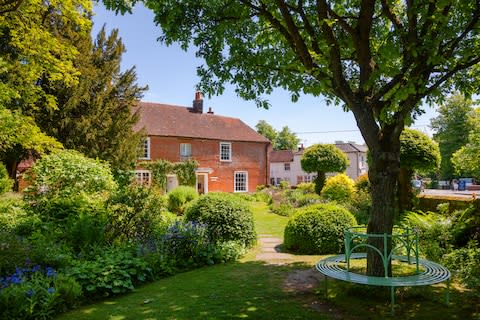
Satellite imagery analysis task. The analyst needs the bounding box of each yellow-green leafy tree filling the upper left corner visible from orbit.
[0,0,92,178]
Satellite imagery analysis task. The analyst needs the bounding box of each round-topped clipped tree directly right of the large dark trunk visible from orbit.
[398,128,440,212]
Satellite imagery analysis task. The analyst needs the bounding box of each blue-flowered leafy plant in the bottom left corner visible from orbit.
[0,265,82,319]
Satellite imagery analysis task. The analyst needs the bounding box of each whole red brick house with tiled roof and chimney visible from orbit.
[135,92,270,193]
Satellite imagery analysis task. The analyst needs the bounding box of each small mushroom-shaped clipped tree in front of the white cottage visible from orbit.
[300,144,349,194]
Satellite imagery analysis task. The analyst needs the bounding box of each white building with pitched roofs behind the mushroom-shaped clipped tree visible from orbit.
[270,141,368,186]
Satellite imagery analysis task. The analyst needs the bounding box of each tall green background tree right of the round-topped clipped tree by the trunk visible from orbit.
[431,93,473,180]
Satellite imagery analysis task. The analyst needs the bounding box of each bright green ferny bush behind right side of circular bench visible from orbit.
[402,211,452,262]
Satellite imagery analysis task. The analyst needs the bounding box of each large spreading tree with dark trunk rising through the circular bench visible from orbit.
[104,0,480,276]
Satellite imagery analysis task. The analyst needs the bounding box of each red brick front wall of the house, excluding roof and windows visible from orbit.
[142,136,270,192]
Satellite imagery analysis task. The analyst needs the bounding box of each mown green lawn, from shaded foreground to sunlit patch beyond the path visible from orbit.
[59,203,480,320]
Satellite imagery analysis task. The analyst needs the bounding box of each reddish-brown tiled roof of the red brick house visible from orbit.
[134,102,269,142]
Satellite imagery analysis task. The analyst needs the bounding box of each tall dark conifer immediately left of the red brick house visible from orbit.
[36,27,146,169]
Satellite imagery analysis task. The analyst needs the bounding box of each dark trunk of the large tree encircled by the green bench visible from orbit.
[367,148,400,277]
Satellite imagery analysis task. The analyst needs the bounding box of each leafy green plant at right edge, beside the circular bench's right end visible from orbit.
[442,241,480,289]
